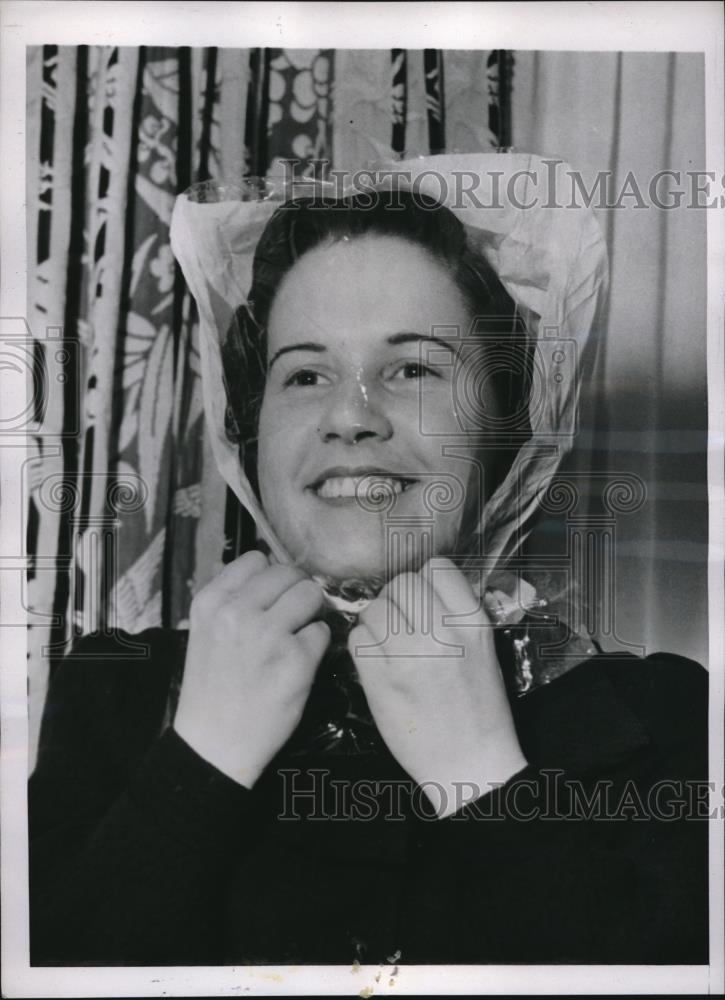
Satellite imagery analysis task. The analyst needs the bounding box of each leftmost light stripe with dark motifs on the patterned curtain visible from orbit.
[26,46,78,757]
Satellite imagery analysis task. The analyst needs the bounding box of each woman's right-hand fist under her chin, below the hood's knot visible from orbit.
[349,559,527,816]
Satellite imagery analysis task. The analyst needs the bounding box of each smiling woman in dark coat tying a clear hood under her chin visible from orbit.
[30,157,707,965]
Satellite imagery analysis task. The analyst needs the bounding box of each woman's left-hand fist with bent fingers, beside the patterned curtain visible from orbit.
[174,552,330,788]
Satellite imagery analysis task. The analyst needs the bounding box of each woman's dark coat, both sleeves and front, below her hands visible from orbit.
[29,629,708,965]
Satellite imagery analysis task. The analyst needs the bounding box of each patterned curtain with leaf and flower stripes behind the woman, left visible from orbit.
[27,45,513,764]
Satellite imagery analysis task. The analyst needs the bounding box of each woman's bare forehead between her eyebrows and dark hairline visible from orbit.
[269,235,469,342]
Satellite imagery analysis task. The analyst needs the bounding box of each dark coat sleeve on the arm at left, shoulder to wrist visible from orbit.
[29,630,264,965]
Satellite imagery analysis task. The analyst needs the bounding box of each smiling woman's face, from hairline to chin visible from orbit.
[258,235,493,582]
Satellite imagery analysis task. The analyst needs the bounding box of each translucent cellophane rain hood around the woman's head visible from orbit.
[171,152,607,636]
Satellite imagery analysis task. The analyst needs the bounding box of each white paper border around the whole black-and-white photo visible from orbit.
[0,0,725,997]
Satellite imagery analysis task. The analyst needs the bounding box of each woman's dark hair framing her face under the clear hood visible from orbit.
[222,190,530,492]
